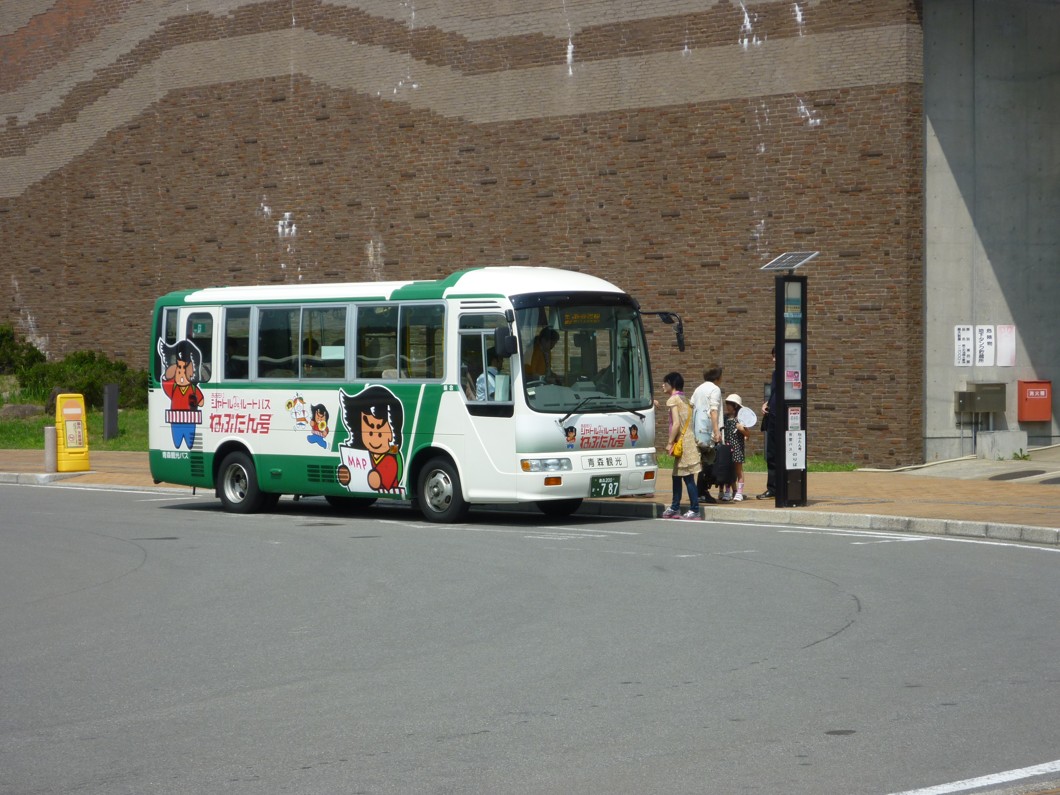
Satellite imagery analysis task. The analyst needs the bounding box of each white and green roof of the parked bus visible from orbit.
[160,265,622,304]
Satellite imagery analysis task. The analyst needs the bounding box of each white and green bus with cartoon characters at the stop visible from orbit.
[148,266,657,523]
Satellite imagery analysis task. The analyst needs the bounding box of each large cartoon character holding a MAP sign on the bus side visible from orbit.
[336,386,405,494]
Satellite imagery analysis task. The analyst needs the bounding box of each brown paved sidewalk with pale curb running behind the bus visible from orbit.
[0,445,1060,546]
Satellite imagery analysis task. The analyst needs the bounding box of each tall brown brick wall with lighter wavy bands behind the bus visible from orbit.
[0,0,924,466]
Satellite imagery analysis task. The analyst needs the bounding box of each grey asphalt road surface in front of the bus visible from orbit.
[0,485,1060,795]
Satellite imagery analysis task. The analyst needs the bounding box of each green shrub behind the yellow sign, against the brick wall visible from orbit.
[18,351,147,408]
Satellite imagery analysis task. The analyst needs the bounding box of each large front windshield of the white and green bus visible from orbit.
[512,293,652,413]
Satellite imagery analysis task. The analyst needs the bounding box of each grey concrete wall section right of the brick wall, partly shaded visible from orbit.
[923,0,1060,460]
